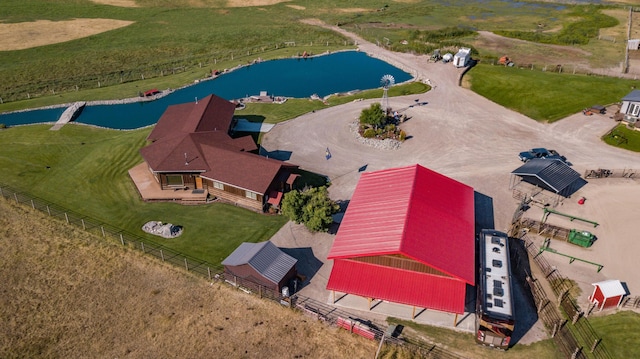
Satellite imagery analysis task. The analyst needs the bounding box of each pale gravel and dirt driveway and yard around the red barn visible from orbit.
[262,21,640,343]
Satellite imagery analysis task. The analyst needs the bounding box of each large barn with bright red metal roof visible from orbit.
[327,165,475,314]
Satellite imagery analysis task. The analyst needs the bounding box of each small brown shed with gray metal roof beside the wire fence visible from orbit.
[222,241,298,292]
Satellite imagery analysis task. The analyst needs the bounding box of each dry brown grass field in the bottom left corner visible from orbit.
[0,198,377,358]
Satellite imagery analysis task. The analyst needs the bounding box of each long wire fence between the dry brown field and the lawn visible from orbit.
[0,184,463,359]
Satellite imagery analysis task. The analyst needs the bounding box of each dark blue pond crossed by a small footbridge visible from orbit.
[0,51,412,129]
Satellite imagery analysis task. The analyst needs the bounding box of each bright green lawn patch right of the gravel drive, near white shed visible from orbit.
[467,64,640,122]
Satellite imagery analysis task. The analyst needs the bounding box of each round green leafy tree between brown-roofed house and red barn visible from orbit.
[282,186,340,232]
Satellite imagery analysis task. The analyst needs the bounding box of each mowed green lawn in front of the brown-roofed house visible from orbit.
[0,125,286,264]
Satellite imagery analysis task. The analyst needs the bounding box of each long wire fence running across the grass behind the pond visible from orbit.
[0,39,355,103]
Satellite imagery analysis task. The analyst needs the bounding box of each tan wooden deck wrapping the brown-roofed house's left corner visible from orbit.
[129,162,209,203]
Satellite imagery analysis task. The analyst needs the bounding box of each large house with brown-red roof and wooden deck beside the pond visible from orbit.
[129,95,297,212]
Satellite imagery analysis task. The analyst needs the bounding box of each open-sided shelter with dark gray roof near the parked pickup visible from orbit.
[511,158,587,198]
